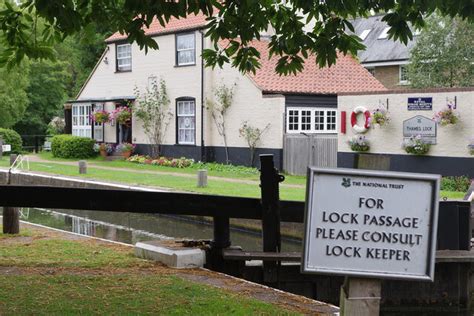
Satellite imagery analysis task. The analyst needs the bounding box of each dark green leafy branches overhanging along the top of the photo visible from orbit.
[0,0,474,74]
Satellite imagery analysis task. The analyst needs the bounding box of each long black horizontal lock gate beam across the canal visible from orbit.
[0,185,304,222]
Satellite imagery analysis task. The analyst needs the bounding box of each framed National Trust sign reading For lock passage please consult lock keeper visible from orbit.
[301,168,440,281]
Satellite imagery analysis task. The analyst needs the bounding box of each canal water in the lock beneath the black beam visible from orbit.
[0,208,301,251]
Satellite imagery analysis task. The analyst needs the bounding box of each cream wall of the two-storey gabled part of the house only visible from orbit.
[78,31,201,145]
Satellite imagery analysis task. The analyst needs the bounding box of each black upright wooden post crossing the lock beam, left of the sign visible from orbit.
[260,155,284,283]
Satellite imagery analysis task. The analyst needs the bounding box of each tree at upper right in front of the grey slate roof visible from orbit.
[408,15,474,88]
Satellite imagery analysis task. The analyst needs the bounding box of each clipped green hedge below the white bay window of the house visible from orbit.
[51,135,97,159]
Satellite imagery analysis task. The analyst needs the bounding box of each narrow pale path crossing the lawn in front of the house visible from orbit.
[28,155,305,189]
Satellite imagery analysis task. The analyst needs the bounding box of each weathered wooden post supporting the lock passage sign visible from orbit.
[339,154,390,316]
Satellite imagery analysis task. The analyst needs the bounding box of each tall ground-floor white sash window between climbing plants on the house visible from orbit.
[176,99,196,145]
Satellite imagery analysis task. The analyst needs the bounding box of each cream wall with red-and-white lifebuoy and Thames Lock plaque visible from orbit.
[338,89,474,157]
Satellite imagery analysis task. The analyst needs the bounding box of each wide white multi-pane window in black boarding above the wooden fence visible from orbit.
[286,107,337,134]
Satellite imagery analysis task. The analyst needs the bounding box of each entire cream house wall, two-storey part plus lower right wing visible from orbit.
[78,31,285,148]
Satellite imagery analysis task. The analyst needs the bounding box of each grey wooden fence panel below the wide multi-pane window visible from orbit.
[283,134,337,175]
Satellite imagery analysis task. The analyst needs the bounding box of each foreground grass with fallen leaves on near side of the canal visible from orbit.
[0,226,296,315]
